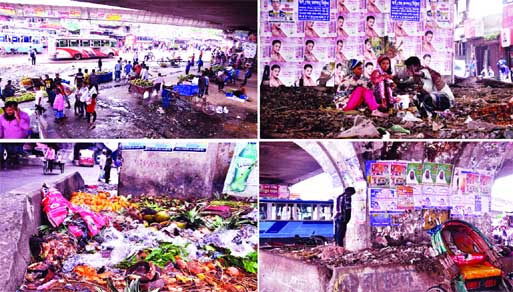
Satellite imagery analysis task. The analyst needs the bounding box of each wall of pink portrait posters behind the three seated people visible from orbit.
[259,0,454,86]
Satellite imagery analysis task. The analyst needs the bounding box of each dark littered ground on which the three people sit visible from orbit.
[261,78,513,139]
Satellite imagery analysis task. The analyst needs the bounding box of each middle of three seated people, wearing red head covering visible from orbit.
[370,55,395,111]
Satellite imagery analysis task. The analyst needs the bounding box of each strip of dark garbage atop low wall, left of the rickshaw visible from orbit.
[262,244,443,274]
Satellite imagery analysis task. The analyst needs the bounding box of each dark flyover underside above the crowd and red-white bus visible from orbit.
[77,0,258,31]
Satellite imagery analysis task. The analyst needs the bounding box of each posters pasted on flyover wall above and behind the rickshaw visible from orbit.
[366,161,494,245]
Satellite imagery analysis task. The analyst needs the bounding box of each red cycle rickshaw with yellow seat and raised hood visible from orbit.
[426,220,513,292]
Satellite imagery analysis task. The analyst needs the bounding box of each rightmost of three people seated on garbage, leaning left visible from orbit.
[405,56,454,118]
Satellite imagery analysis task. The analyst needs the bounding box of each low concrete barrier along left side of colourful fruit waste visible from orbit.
[0,172,84,291]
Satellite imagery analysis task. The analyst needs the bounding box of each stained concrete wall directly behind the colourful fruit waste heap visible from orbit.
[119,143,234,199]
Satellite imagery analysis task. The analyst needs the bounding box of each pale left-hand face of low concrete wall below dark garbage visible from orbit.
[258,250,331,292]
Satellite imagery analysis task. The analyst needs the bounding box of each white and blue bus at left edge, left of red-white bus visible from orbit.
[0,31,43,54]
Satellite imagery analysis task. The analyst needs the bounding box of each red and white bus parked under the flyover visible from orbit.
[48,36,119,60]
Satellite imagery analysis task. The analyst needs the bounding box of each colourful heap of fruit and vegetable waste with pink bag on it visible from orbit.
[20,188,258,292]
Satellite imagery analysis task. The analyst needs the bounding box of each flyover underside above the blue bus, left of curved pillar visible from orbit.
[260,142,323,185]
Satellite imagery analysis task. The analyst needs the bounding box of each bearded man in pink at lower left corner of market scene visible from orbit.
[0,100,30,139]
